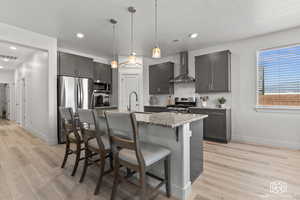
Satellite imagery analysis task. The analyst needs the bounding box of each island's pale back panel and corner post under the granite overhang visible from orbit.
[139,124,191,200]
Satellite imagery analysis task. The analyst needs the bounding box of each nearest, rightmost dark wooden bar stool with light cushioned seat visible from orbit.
[105,112,171,200]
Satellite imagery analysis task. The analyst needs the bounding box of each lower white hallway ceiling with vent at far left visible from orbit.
[0,42,36,70]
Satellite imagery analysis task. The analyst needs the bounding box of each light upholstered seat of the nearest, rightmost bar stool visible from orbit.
[119,142,171,167]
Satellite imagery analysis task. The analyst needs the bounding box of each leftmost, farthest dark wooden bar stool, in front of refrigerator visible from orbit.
[59,107,84,176]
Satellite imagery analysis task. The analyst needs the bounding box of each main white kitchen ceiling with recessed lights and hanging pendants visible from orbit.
[0,0,300,57]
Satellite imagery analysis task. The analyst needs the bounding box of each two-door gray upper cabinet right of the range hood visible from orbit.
[195,50,231,93]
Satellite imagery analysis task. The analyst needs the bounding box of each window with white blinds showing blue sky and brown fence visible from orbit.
[257,45,300,106]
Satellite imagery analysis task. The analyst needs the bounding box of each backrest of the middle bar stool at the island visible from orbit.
[78,109,107,150]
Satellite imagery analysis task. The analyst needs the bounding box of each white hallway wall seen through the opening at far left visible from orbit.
[15,51,49,140]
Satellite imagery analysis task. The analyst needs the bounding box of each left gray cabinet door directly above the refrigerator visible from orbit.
[58,52,77,76]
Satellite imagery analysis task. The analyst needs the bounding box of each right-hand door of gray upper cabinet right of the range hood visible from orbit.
[211,51,229,92]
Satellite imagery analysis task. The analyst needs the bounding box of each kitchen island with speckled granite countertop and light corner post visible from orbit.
[97,109,207,200]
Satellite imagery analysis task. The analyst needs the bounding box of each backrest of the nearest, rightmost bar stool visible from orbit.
[105,111,145,166]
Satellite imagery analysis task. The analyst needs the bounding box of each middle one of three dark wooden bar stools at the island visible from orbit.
[78,109,113,195]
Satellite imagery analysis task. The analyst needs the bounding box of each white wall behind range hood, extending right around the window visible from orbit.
[144,28,300,149]
